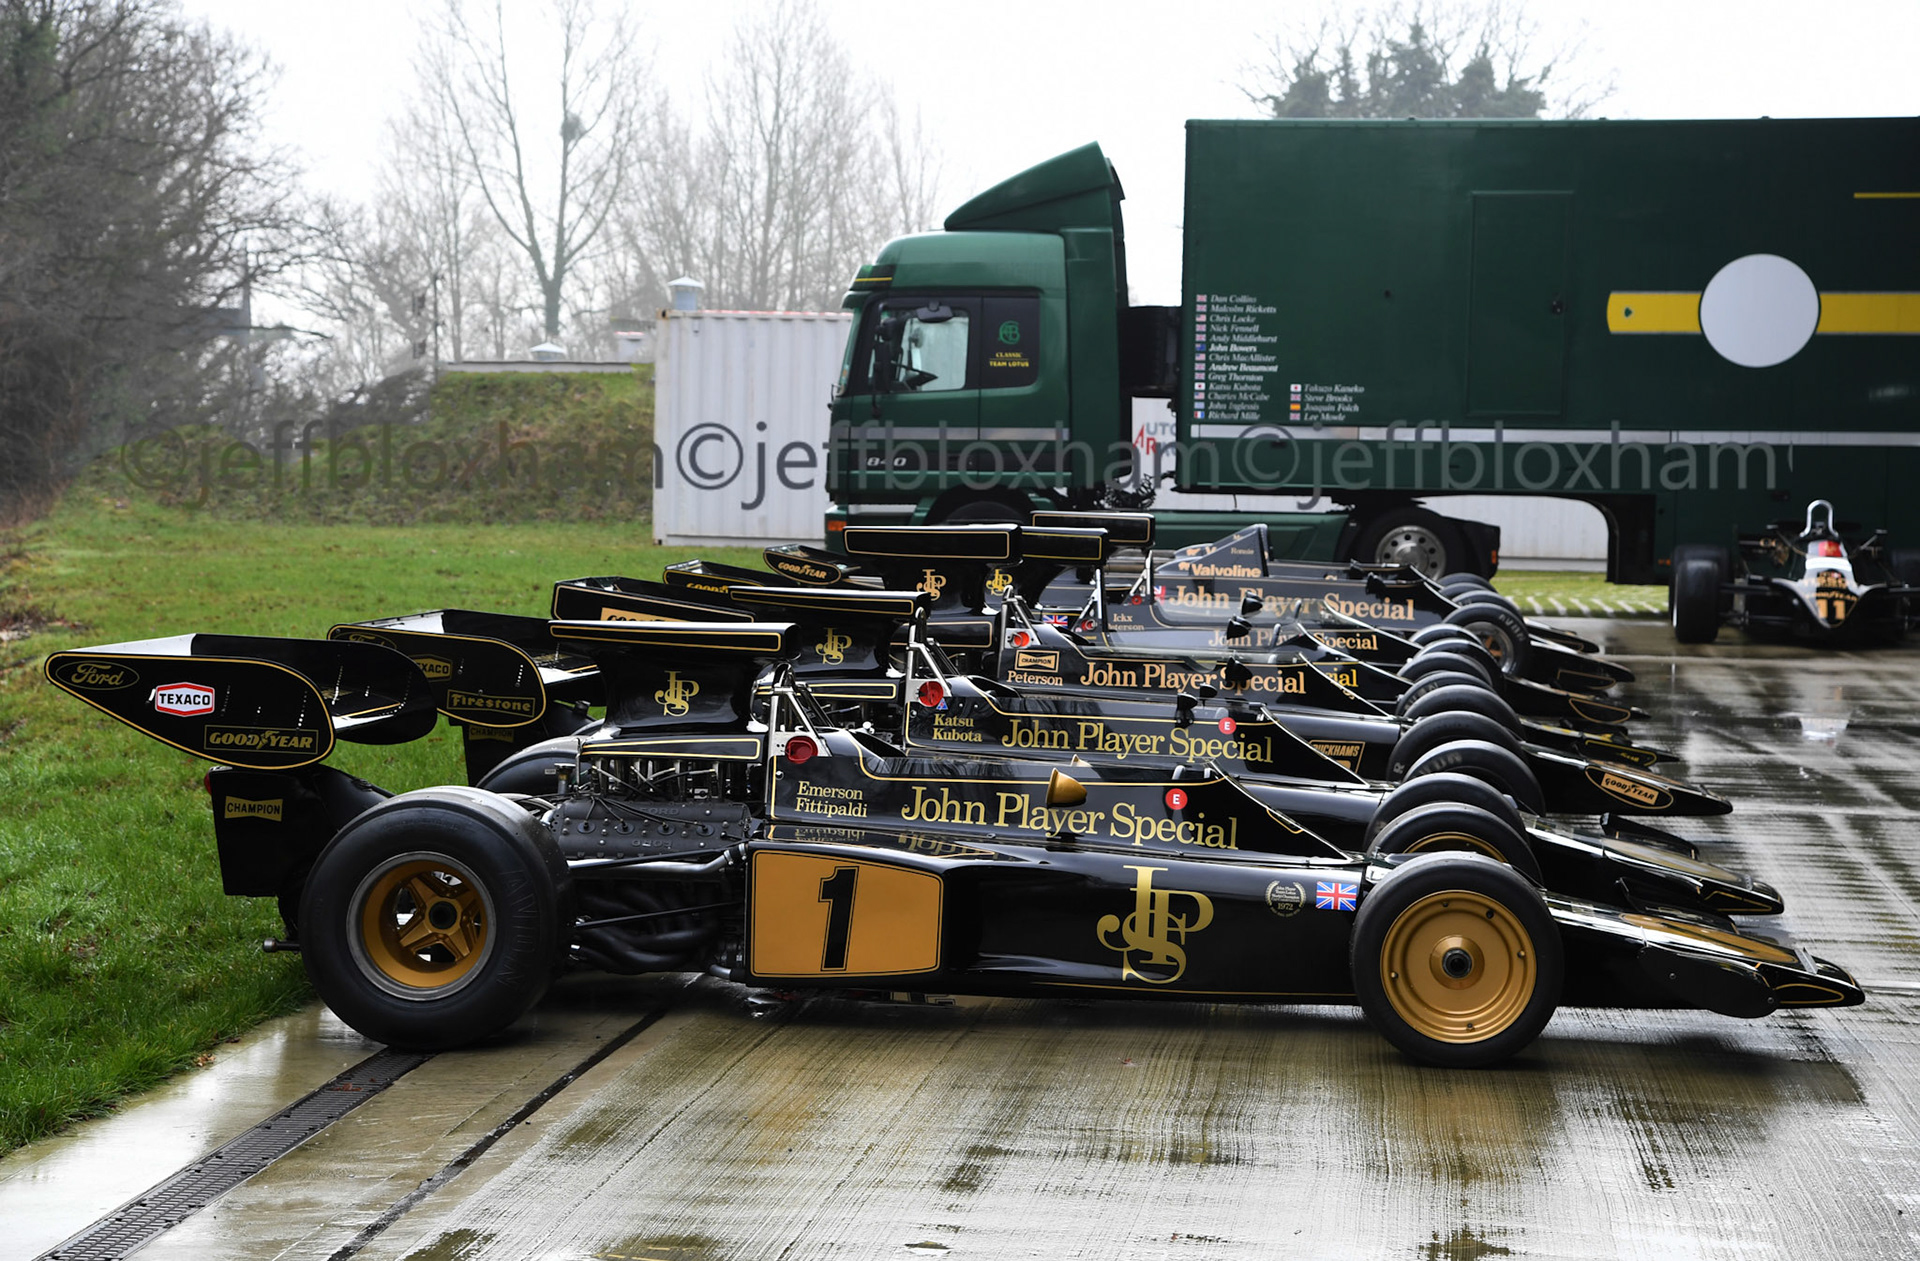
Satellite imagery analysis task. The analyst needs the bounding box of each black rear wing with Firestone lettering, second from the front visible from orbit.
[326,608,601,727]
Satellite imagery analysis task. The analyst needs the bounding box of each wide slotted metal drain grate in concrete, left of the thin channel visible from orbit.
[38,1050,430,1261]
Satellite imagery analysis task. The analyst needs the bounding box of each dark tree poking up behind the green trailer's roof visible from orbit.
[1242,0,1613,119]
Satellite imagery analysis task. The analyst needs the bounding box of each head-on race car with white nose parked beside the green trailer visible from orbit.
[1668,499,1920,643]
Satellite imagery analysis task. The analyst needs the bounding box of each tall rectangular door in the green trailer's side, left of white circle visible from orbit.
[1467,192,1572,416]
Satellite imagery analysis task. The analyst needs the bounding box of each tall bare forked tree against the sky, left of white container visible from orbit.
[426,0,647,340]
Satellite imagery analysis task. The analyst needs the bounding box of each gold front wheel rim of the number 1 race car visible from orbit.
[1380,889,1540,1042]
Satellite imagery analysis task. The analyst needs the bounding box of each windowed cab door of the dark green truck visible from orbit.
[843,294,981,491]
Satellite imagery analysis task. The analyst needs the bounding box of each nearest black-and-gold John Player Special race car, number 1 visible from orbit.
[46,620,1864,1065]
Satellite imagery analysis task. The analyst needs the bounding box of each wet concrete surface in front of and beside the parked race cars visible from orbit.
[11,620,1920,1261]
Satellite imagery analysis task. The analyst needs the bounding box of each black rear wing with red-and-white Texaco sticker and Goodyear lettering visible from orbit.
[46,635,440,770]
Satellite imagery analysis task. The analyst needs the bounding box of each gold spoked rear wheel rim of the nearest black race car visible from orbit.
[348,852,493,1000]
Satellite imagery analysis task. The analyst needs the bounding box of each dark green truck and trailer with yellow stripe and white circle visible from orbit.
[828,119,1920,582]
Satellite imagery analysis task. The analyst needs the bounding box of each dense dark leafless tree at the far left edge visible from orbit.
[0,0,307,516]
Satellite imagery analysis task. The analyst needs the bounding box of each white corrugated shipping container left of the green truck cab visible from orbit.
[653,311,852,547]
